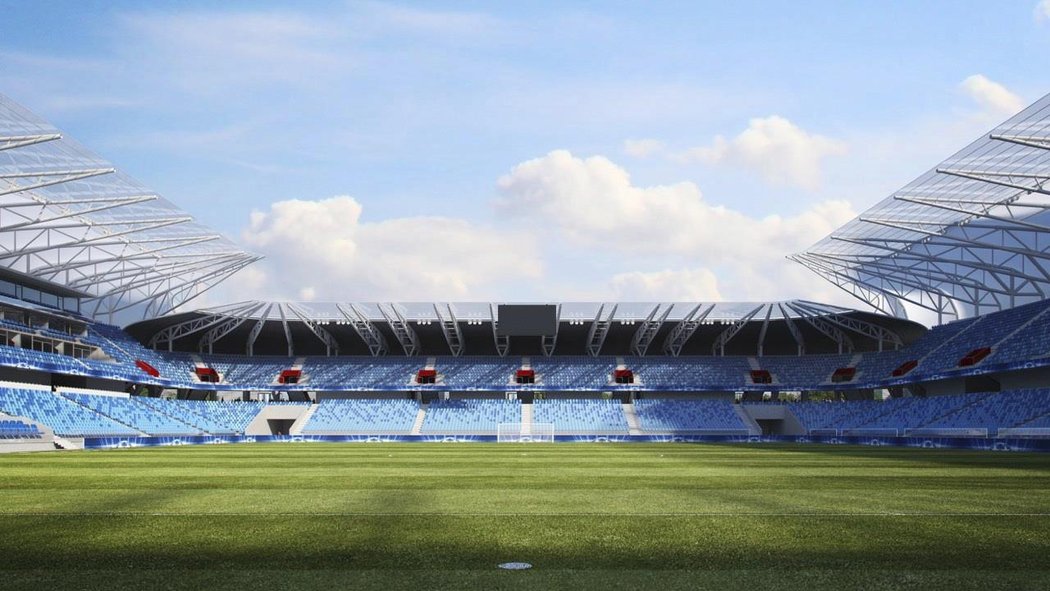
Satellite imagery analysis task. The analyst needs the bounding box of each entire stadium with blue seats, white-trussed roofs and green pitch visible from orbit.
[0,3,1050,589]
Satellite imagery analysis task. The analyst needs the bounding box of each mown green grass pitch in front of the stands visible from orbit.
[0,444,1050,591]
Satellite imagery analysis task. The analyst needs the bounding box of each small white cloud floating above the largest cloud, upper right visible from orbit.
[676,115,846,189]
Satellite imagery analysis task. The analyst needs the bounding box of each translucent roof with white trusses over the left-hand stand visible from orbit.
[0,94,259,322]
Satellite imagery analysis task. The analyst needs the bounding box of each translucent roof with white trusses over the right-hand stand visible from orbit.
[791,94,1050,321]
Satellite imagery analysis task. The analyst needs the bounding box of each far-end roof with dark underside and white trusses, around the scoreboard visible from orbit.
[127,300,924,356]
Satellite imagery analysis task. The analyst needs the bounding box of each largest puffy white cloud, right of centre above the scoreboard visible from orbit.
[497,150,856,299]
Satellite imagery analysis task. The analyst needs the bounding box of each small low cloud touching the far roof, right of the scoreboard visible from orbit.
[609,269,722,301]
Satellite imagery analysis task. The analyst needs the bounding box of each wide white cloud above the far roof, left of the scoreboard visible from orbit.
[233,196,542,301]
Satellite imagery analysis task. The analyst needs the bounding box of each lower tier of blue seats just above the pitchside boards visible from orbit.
[6,387,1050,437]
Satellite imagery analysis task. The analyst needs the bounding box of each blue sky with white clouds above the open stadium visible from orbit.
[0,0,1050,312]
